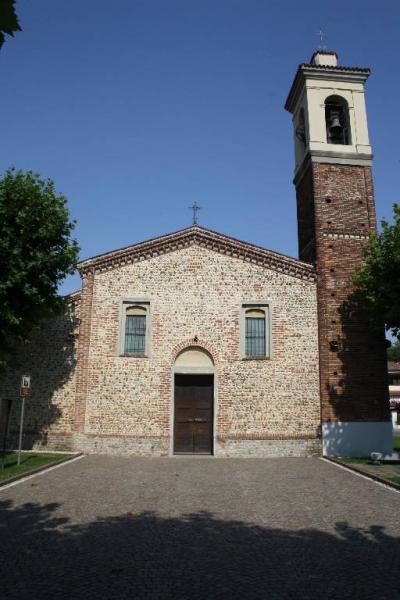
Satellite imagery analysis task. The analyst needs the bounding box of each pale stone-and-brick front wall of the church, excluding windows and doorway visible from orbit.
[75,245,320,456]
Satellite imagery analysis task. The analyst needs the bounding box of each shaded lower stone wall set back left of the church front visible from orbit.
[0,294,80,450]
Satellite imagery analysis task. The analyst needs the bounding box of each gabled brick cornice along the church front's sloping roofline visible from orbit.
[78,225,316,281]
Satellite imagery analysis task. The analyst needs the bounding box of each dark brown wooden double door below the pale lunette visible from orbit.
[174,374,214,454]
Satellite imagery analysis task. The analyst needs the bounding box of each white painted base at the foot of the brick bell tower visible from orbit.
[322,421,392,456]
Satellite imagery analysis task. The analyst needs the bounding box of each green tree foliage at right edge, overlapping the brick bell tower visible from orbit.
[354,204,400,339]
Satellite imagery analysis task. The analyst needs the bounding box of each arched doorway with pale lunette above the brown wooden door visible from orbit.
[173,347,214,454]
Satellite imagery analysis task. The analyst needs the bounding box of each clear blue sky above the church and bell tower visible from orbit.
[0,0,400,293]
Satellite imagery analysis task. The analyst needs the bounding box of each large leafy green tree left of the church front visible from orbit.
[0,169,79,372]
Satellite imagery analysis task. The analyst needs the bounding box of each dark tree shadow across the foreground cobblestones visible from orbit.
[0,501,400,600]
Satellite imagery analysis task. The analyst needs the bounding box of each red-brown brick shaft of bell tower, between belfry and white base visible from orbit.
[296,163,388,421]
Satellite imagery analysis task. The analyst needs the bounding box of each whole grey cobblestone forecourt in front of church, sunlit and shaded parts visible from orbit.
[0,456,400,600]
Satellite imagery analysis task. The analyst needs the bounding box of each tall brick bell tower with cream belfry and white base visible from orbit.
[285,51,391,456]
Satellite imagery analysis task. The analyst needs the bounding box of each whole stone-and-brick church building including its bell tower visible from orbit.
[2,52,391,457]
